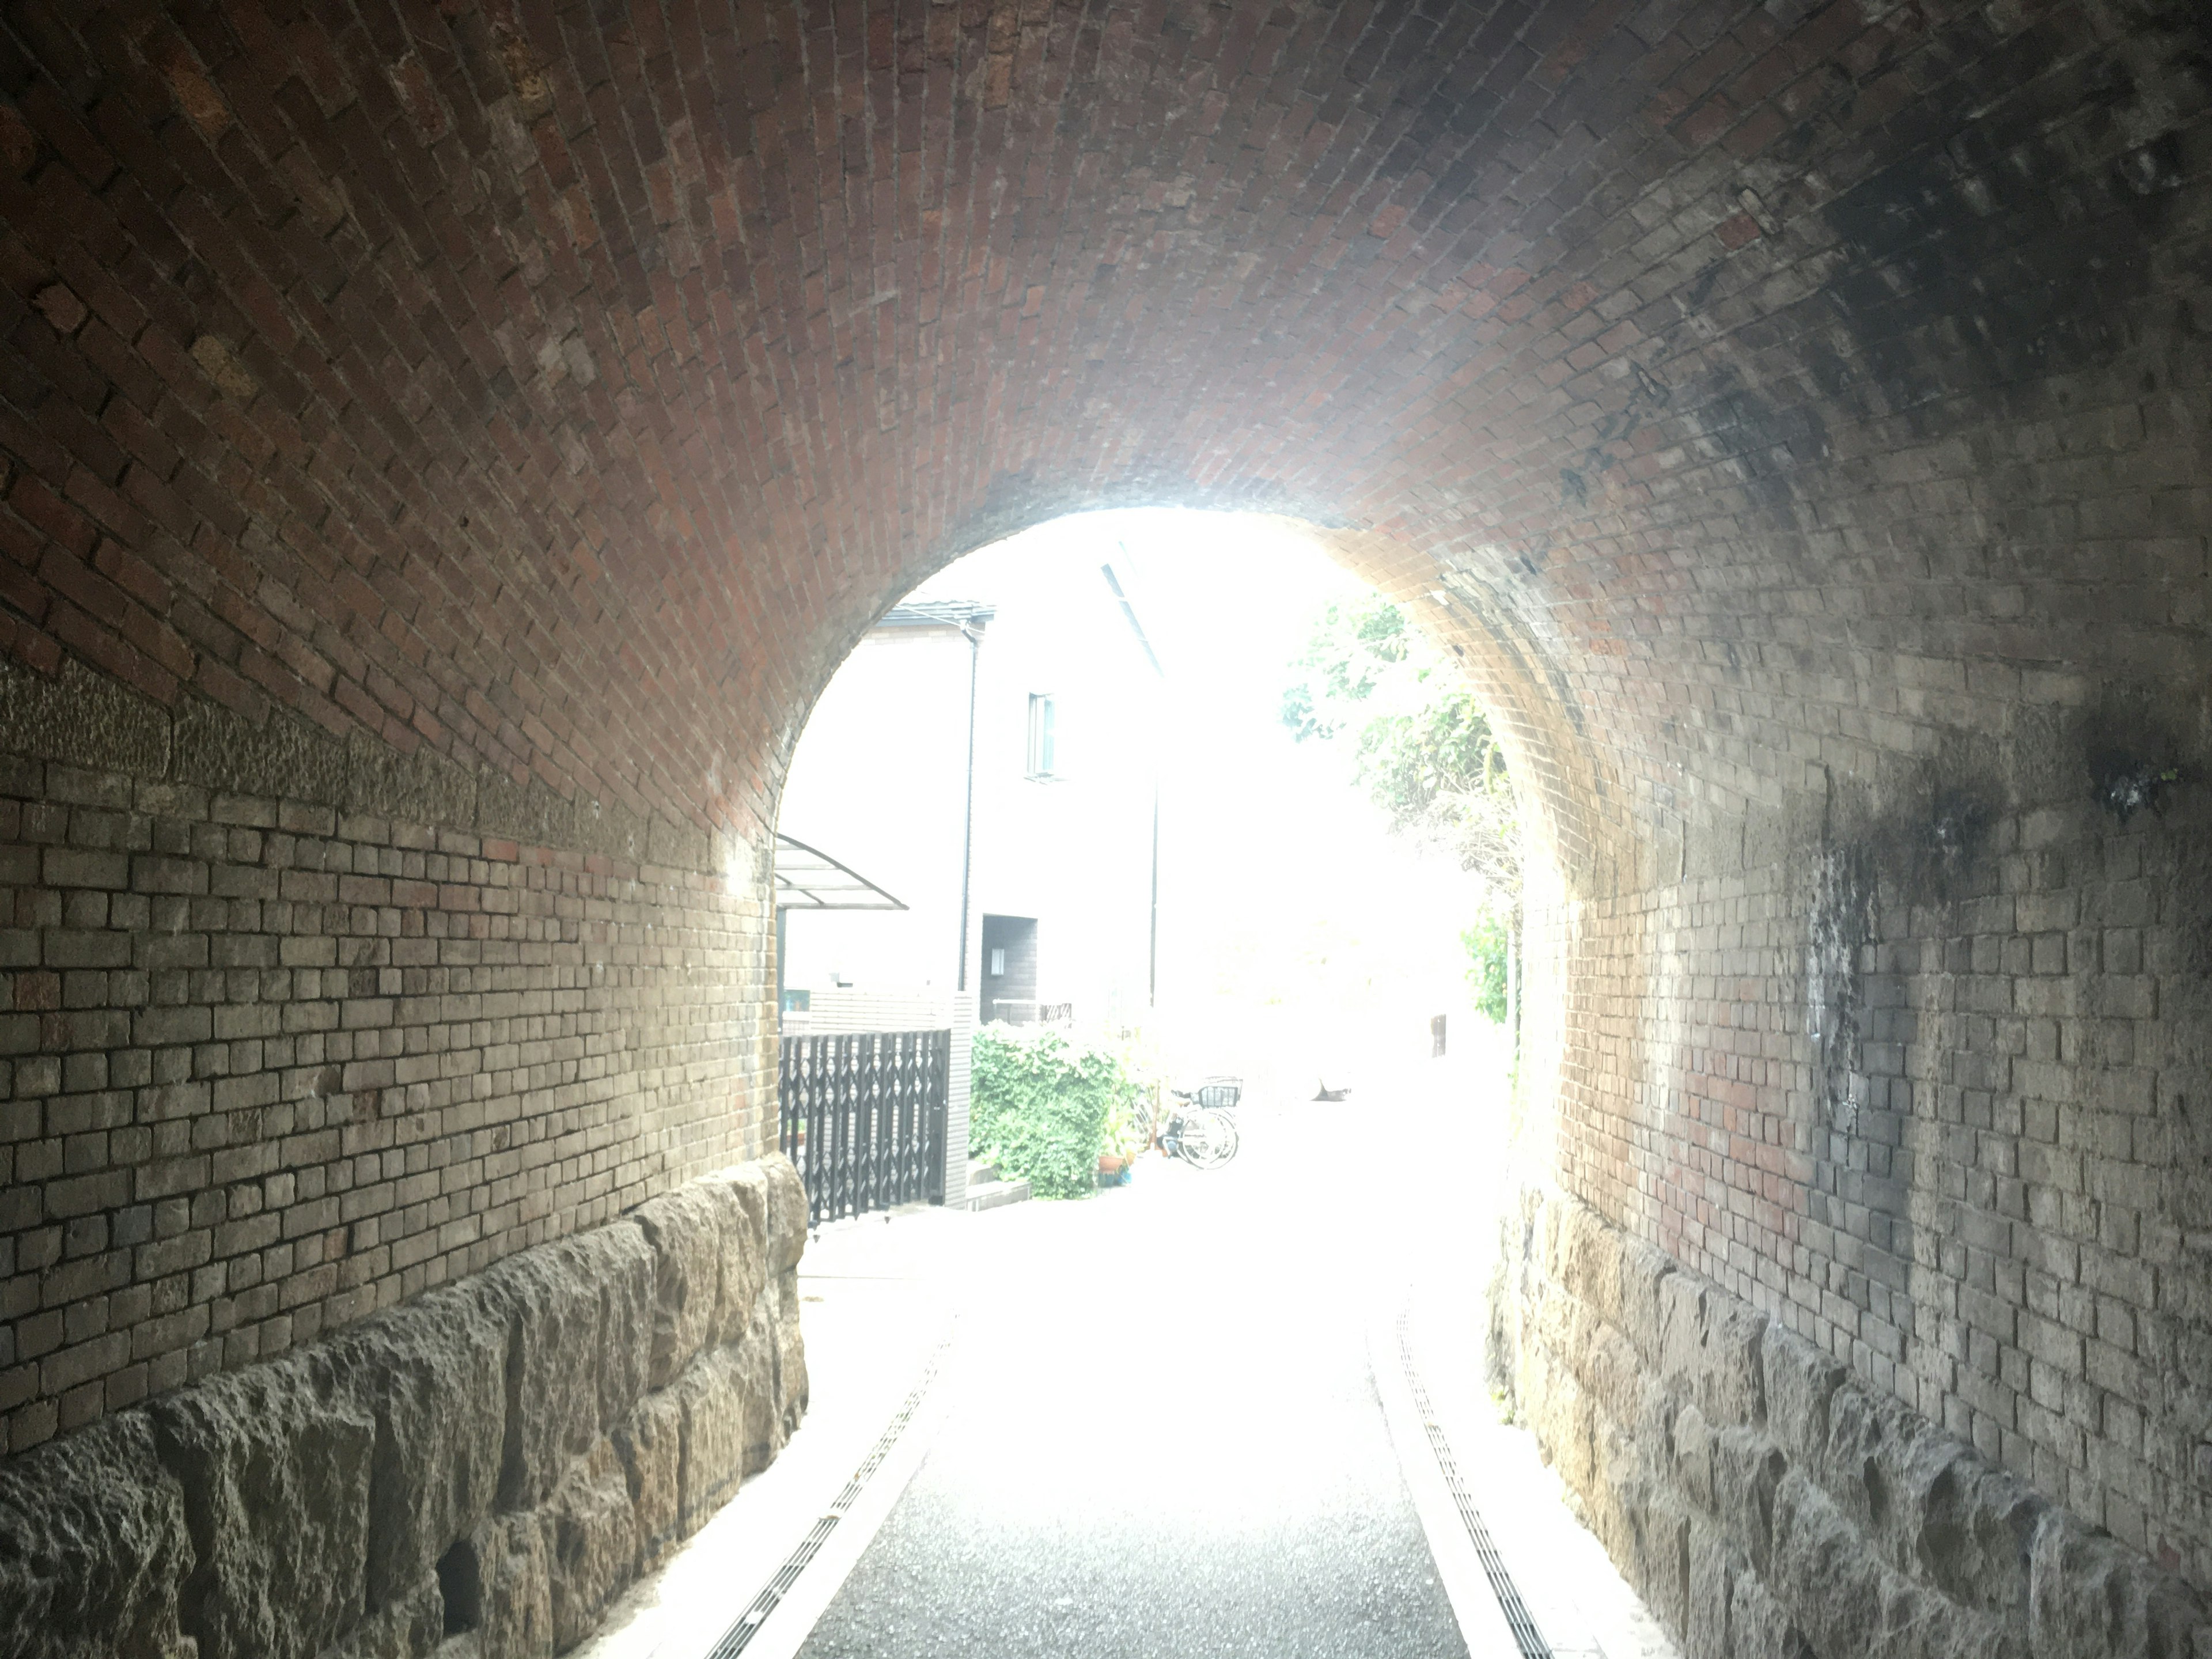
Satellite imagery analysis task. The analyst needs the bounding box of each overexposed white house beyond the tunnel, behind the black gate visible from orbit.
[779,548,1164,1183]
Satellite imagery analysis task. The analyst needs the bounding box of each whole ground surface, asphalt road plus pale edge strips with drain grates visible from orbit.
[573,1052,1675,1659]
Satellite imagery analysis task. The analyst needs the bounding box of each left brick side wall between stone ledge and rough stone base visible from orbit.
[0,738,774,1451]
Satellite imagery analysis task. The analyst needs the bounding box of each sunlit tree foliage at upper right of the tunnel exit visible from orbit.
[1283,595,1520,889]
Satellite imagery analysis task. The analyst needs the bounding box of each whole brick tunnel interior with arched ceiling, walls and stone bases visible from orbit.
[0,0,2212,1659]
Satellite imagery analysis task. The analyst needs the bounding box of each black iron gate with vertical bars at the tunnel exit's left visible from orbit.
[779,1031,953,1225]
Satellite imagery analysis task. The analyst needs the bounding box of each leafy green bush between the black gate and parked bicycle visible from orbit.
[969,1024,1137,1199]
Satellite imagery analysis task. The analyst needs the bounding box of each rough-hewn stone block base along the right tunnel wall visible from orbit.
[1493,1190,2212,1659]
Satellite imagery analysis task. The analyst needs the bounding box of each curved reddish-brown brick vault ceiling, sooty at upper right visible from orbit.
[0,0,2205,858]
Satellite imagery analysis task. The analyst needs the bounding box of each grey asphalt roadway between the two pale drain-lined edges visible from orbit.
[801,1084,1467,1659]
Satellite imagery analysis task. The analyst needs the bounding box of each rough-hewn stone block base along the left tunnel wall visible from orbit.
[0,1157,808,1659]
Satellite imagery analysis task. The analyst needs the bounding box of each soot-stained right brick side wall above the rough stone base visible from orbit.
[1535,787,2212,1586]
